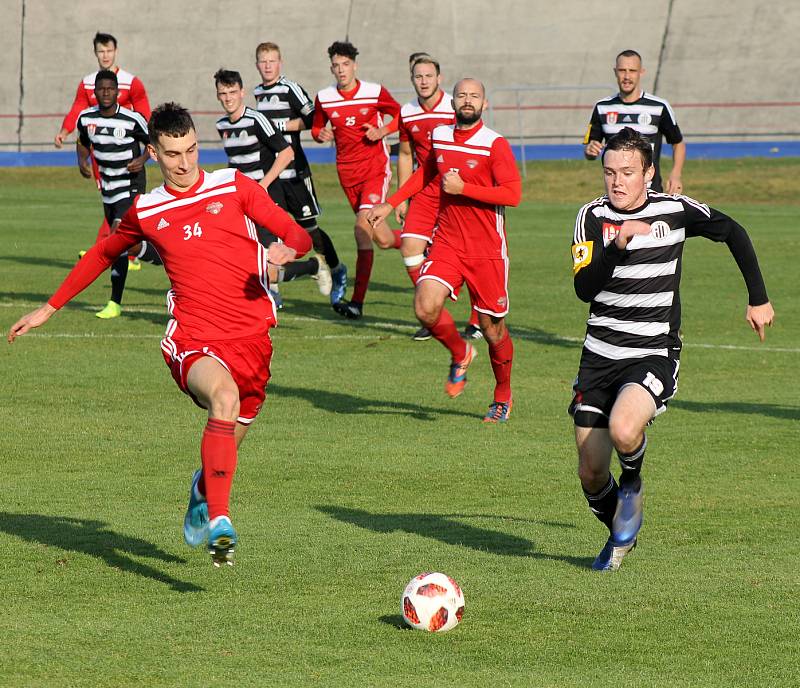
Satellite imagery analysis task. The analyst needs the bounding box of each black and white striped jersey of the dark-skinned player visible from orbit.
[76,105,148,204]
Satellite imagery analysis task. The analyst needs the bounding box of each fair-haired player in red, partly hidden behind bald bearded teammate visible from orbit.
[395,53,482,341]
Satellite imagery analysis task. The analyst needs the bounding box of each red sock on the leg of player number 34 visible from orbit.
[198,418,236,519]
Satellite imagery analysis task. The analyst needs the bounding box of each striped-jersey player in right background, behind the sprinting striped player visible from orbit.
[583,50,686,193]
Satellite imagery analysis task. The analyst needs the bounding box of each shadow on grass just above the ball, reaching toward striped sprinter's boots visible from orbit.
[315,504,593,568]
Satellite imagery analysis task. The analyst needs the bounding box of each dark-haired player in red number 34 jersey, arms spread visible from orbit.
[13,103,311,566]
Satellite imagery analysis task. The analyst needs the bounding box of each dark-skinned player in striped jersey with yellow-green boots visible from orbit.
[76,70,151,320]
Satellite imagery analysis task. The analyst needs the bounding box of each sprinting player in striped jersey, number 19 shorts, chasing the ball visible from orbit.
[570,128,774,571]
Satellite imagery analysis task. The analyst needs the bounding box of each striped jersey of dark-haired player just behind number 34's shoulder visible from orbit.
[217,107,289,181]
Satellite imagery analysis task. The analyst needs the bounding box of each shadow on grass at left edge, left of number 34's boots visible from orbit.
[0,511,203,592]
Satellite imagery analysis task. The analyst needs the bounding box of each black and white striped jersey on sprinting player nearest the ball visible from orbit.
[572,191,768,360]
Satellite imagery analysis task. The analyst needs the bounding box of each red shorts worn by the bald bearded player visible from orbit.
[417,243,508,318]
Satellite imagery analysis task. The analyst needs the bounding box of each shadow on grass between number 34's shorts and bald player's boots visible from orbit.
[269,383,478,421]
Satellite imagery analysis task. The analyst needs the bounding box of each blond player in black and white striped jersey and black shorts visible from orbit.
[253,42,347,304]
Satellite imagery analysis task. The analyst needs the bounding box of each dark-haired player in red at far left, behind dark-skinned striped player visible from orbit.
[54,32,150,269]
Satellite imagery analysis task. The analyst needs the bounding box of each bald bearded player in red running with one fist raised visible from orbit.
[369,79,522,423]
